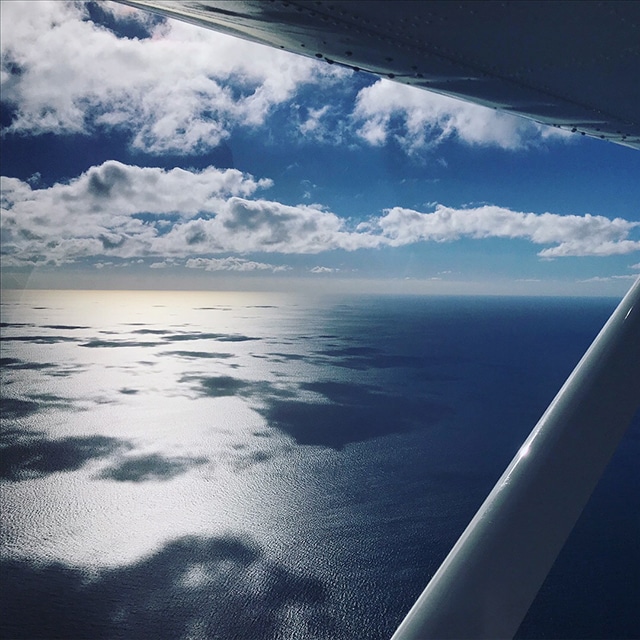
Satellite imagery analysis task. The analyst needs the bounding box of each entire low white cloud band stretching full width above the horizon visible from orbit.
[2,161,640,272]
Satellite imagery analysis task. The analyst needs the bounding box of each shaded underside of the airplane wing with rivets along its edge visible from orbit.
[115,0,640,149]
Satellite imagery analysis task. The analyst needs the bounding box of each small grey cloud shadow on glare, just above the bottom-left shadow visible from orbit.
[98,453,208,482]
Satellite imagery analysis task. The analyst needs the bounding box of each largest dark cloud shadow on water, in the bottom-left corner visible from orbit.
[0,536,334,640]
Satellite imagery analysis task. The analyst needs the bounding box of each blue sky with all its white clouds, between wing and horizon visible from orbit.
[1,1,640,296]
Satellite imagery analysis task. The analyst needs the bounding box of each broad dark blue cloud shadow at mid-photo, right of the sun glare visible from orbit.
[261,381,453,449]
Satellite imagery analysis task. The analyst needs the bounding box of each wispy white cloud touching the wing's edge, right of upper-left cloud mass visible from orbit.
[352,80,568,153]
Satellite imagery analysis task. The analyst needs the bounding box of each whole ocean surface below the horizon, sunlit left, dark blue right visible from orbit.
[0,291,640,640]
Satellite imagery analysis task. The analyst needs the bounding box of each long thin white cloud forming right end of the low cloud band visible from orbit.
[375,205,640,258]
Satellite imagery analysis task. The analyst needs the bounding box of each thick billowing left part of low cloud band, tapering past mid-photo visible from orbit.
[2,161,380,270]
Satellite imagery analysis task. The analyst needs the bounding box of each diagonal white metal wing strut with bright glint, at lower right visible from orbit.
[392,278,640,640]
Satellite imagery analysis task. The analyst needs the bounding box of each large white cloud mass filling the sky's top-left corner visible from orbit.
[1,1,348,153]
